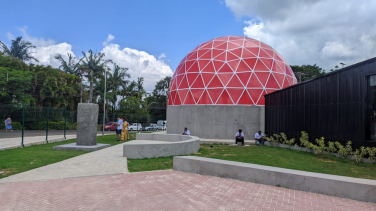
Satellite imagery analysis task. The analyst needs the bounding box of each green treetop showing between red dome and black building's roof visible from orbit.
[290,64,325,83]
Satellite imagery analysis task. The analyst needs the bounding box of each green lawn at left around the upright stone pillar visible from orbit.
[0,133,136,179]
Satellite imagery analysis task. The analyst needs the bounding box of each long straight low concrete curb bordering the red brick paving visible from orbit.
[173,156,376,203]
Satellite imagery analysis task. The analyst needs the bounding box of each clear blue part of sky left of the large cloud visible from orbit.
[0,0,244,70]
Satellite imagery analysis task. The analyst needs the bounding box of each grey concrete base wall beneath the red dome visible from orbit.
[167,105,265,140]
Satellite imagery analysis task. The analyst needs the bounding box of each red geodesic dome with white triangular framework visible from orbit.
[168,36,297,105]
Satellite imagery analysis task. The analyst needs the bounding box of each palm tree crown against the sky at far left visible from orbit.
[0,37,39,62]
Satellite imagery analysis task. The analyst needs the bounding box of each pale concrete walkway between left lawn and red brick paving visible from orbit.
[0,144,128,183]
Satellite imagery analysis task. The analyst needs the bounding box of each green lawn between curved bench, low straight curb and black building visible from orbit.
[128,145,376,180]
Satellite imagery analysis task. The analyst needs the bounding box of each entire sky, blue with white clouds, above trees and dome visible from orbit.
[0,0,376,91]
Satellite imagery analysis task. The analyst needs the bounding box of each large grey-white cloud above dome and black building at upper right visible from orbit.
[225,0,376,70]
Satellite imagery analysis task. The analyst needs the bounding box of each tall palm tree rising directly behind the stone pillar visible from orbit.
[79,49,112,103]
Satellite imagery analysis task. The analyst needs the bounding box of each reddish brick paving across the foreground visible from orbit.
[0,170,376,211]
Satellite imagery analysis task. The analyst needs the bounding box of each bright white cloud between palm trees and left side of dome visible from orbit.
[102,44,173,92]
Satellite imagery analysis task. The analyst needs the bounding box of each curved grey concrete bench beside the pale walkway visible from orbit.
[123,133,200,159]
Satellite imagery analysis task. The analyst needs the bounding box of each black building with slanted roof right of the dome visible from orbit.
[265,58,376,148]
